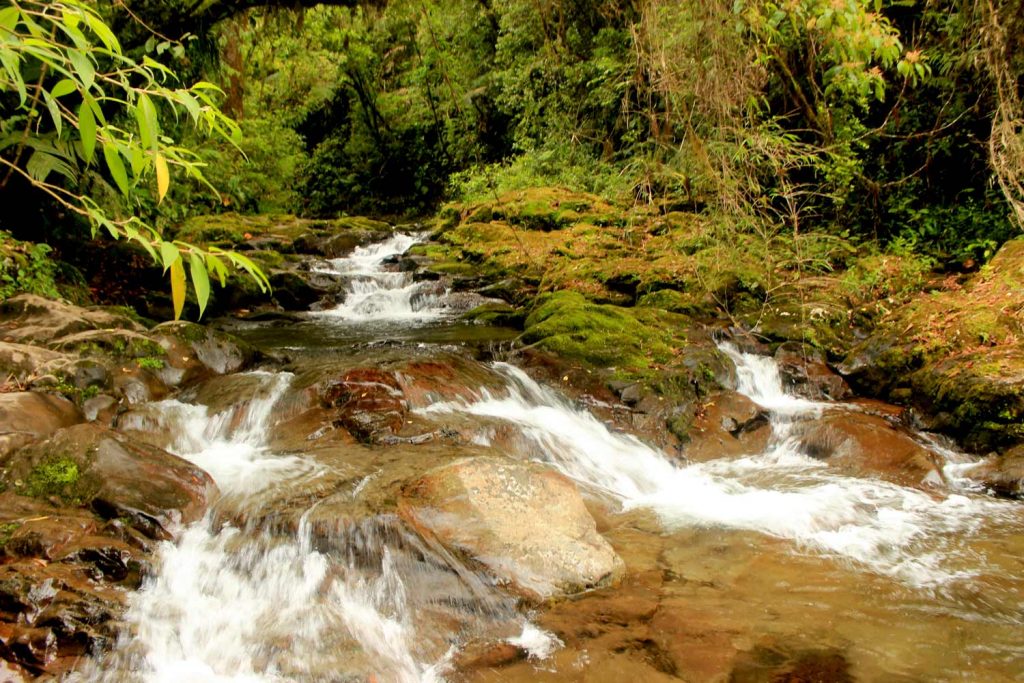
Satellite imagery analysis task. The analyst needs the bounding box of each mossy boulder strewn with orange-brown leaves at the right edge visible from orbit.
[840,240,1024,451]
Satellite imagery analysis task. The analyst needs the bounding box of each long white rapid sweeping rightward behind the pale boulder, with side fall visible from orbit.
[424,348,1017,589]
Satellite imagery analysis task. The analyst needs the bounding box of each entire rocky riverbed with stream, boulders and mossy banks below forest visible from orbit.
[0,211,1024,681]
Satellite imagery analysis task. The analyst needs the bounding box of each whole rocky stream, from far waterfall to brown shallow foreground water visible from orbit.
[74,234,1024,682]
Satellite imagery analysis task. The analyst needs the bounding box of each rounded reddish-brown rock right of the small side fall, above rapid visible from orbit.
[797,411,943,485]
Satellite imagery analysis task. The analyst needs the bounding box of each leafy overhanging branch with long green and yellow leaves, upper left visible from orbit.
[0,0,267,316]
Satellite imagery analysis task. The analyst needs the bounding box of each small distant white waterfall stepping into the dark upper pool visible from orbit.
[317,232,445,323]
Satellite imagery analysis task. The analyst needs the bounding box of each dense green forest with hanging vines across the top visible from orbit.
[6,0,1024,287]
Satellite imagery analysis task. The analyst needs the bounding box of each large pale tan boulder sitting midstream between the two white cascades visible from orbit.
[398,457,625,600]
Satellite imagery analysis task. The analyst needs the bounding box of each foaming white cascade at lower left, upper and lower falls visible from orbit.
[86,373,454,683]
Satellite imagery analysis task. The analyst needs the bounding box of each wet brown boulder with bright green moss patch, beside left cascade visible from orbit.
[3,423,216,539]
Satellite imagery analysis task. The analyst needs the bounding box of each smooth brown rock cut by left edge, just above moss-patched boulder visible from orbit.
[0,391,83,456]
